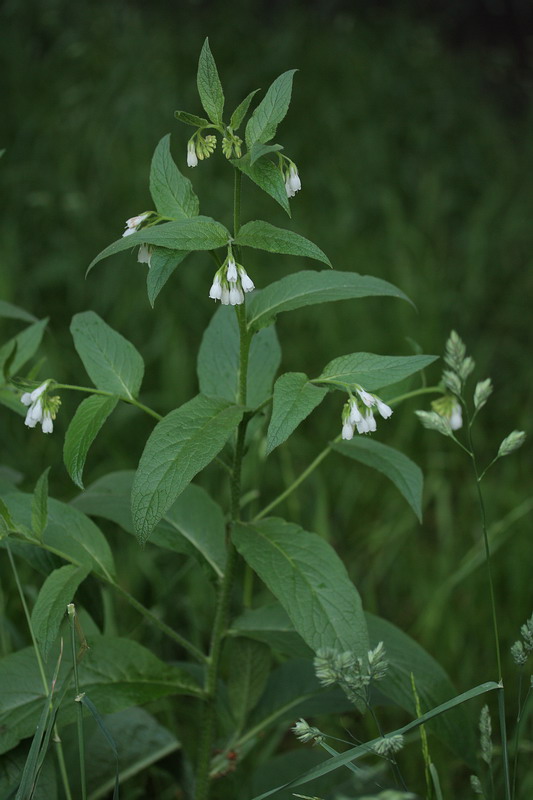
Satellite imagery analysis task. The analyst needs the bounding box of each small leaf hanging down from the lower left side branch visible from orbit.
[31,564,89,661]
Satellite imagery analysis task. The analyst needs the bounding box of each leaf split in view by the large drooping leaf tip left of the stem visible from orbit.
[72,470,226,577]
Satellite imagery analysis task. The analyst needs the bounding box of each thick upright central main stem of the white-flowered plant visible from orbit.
[195,170,253,800]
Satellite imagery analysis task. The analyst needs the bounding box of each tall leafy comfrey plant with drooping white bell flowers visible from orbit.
[0,40,520,800]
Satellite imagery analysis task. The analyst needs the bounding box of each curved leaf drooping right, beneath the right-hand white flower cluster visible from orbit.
[331,436,424,522]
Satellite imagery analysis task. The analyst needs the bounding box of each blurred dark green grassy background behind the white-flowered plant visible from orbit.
[0,0,533,796]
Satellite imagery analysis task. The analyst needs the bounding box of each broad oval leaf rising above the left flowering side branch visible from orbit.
[70,311,144,399]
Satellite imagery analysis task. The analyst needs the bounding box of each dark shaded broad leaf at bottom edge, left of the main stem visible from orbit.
[81,708,180,800]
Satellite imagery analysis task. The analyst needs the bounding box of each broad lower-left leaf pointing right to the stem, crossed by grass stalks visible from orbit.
[0,636,200,753]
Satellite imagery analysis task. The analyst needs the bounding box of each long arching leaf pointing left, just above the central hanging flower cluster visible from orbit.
[86,216,231,275]
